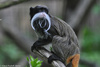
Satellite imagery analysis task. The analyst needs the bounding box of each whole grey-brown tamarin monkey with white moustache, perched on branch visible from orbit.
[30,5,80,67]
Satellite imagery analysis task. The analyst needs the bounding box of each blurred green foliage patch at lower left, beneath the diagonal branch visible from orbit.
[0,38,25,65]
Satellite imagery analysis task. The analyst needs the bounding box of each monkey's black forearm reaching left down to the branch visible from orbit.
[31,37,52,52]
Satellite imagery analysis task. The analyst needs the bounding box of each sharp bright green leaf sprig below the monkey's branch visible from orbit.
[27,56,42,67]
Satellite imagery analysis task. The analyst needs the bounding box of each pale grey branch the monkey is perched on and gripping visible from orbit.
[33,48,66,67]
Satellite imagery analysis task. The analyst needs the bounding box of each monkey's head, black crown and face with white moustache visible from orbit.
[30,6,51,32]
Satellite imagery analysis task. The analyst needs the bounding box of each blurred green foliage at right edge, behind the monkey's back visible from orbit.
[81,27,100,64]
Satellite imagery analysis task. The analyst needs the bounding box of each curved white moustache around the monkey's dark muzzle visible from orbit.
[31,12,51,31]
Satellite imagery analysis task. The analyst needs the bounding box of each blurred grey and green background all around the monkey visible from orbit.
[0,0,100,67]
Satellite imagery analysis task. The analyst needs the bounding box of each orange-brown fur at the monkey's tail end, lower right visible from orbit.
[66,54,80,67]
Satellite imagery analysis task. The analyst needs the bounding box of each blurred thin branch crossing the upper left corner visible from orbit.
[0,0,30,9]
